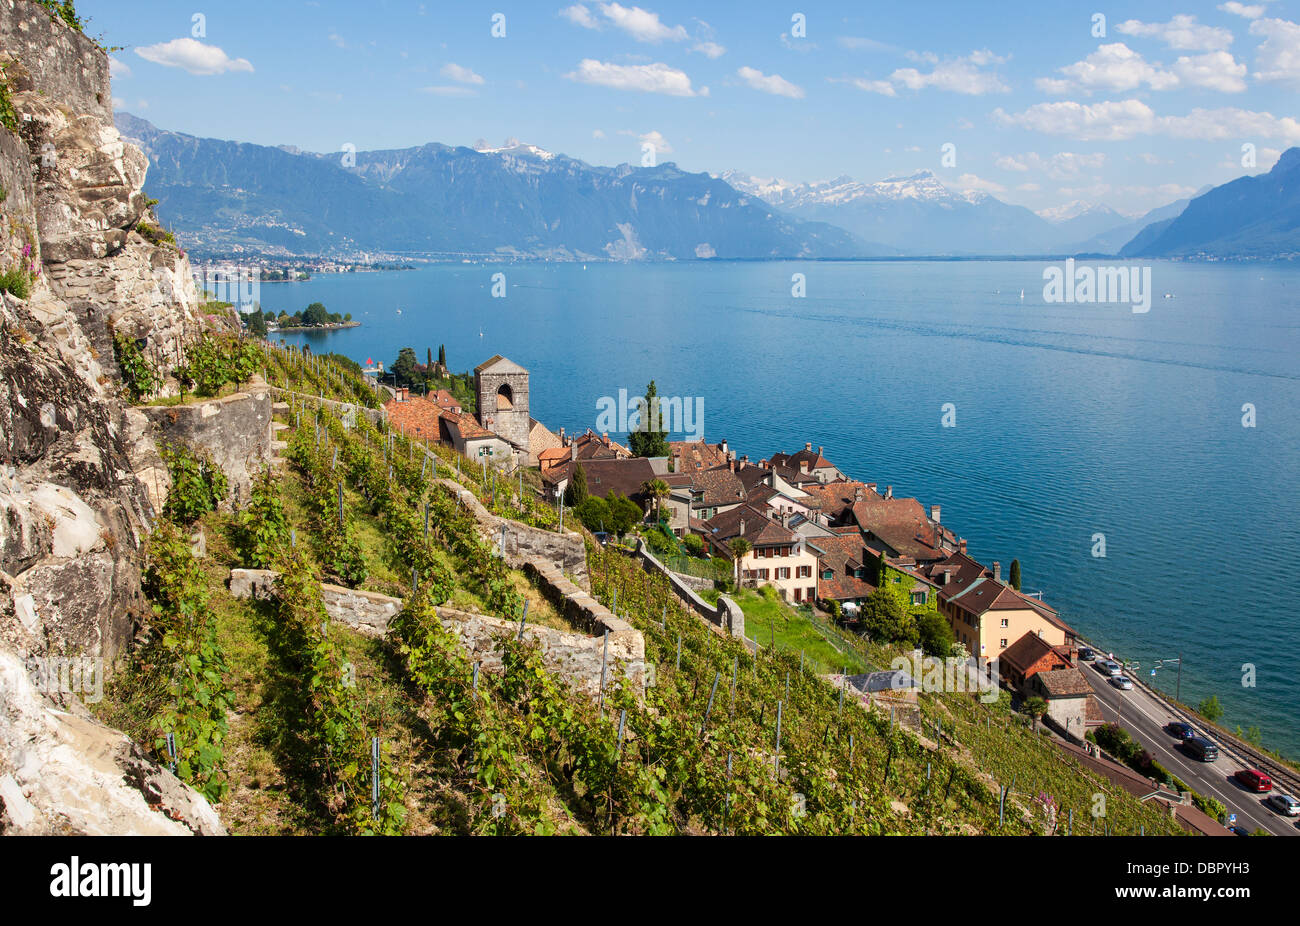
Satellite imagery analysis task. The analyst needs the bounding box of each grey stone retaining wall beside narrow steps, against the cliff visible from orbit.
[142,385,272,501]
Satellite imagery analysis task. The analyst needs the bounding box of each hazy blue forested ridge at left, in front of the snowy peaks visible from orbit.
[118,113,887,260]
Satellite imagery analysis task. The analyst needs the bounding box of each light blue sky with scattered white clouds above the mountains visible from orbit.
[86,0,1300,216]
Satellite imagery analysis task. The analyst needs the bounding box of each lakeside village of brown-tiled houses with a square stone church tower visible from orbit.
[379,355,1102,741]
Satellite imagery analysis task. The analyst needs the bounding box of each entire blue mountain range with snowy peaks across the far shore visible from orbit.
[116,113,1300,260]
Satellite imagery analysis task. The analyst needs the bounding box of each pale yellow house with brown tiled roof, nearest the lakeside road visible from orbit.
[917,542,1078,659]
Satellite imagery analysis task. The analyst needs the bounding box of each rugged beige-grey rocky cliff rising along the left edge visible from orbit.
[0,0,220,832]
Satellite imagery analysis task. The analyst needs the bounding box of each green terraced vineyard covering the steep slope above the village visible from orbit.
[101,350,1190,835]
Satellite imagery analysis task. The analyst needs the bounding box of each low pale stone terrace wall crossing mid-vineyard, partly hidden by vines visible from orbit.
[230,563,646,697]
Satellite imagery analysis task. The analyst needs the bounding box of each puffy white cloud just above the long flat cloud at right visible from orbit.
[1036,42,1245,94]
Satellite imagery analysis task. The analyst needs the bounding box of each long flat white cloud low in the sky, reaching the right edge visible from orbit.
[993,100,1300,143]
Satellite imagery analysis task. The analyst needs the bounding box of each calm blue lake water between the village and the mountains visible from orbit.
[261,261,1300,754]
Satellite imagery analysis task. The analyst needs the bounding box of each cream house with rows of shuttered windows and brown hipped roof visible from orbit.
[698,502,816,602]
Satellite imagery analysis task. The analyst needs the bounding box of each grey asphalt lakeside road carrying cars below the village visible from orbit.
[1079,662,1300,836]
